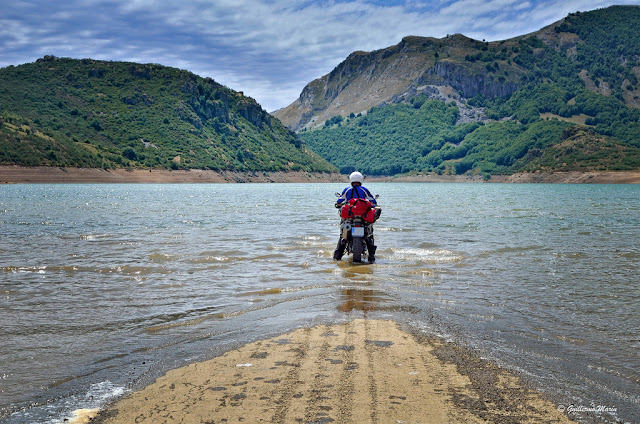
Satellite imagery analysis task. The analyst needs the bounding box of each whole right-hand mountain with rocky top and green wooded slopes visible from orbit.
[284,6,640,174]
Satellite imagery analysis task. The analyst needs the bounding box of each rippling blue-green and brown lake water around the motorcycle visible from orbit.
[0,183,640,423]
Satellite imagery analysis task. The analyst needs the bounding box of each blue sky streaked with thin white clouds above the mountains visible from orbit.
[0,0,640,112]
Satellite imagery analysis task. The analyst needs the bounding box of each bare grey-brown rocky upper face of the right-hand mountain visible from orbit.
[274,34,519,130]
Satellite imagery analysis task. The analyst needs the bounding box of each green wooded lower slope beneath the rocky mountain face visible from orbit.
[301,97,640,175]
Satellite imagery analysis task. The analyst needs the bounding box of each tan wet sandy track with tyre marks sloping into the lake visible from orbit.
[86,320,572,424]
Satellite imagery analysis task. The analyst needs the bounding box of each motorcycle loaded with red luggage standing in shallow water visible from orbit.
[334,193,382,262]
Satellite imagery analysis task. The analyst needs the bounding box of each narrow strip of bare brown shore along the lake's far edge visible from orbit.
[0,165,640,184]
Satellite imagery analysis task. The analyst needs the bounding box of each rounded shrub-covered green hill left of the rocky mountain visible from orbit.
[0,56,334,172]
